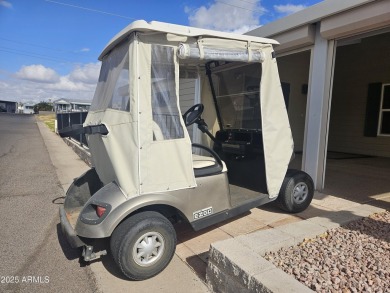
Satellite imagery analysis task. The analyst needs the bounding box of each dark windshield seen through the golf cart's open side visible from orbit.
[212,63,261,130]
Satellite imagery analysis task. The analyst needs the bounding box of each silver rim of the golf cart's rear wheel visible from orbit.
[133,232,165,267]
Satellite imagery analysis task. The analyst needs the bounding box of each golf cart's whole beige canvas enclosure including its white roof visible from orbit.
[84,21,293,197]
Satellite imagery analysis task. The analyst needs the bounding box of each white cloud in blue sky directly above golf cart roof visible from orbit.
[184,0,266,33]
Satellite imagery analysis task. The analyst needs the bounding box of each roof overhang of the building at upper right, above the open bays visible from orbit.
[247,0,390,53]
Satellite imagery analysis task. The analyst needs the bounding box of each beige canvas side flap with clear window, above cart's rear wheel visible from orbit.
[137,35,196,194]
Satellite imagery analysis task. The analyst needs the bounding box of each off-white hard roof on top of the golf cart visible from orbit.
[99,20,279,60]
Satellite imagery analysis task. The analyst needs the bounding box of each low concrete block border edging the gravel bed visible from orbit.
[206,204,385,293]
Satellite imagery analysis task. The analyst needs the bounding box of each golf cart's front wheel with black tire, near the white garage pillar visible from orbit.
[276,170,314,213]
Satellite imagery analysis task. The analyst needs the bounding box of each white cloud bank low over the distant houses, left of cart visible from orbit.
[0,63,100,103]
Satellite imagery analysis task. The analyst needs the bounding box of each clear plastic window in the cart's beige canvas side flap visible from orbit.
[151,45,184,140]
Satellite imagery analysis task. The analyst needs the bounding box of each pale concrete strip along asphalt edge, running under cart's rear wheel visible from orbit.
[38,122,209,293]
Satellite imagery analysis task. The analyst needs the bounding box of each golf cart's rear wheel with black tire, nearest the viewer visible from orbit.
[110,211,176,281]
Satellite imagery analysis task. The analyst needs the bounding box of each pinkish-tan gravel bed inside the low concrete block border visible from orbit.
[265,211,390,293]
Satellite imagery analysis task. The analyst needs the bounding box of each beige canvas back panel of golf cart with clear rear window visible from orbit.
[84,39,139,197]
